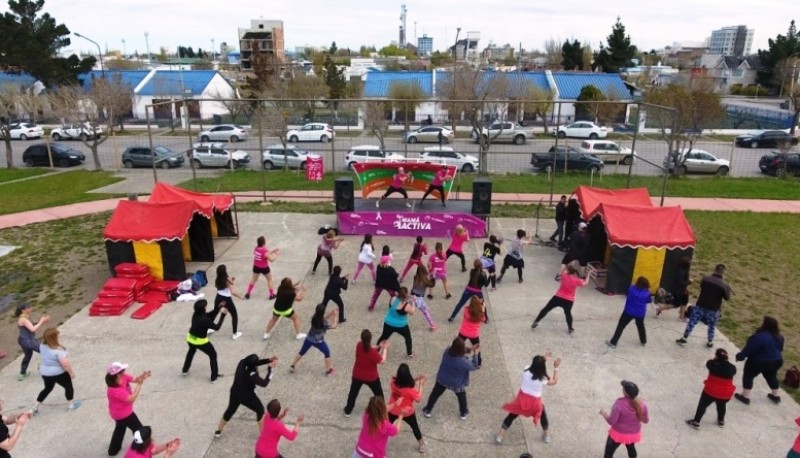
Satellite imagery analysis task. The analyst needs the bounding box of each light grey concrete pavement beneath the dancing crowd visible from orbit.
[0,213,798,457]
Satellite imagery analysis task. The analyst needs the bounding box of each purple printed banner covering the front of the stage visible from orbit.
[336,211,487,238]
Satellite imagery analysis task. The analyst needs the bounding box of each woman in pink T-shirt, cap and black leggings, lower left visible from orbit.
[106,362,150,456]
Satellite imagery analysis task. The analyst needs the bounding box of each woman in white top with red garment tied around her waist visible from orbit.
[494,352,561,445]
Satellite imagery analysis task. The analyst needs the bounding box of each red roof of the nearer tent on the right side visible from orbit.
[597,203,697,249]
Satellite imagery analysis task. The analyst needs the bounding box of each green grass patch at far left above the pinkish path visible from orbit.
[0,170,122,215]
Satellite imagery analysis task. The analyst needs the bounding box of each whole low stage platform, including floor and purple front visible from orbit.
[336,196,489,238]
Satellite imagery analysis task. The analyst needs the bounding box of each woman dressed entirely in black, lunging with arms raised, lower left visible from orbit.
[214,353,278,437]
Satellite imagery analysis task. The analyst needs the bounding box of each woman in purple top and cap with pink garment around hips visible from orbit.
[600,380,650,458]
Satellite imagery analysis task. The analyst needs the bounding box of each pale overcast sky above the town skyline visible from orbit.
[21,0,800,54]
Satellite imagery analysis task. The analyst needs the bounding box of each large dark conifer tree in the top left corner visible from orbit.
[0,0,96,88]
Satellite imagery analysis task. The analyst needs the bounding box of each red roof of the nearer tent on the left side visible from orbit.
[103,200,200,242]
